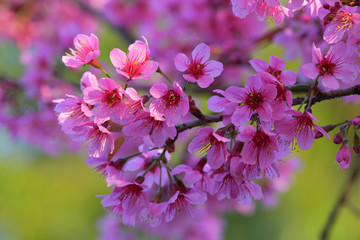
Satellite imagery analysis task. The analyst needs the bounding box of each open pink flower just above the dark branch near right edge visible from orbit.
[301,43,354,89]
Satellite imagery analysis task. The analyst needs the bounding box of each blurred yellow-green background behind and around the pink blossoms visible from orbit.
[0,1,360,240]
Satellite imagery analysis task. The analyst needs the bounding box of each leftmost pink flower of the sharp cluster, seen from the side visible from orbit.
[54,95,93,134]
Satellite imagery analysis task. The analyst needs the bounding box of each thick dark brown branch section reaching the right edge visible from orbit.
[293,85,360,106]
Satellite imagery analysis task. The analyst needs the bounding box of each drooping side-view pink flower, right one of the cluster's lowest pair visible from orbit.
[149,190,207,222]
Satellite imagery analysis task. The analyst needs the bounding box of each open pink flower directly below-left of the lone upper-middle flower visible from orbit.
[149,81,189,126]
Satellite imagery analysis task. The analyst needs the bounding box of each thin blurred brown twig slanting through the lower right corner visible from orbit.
[320,159,360,240]
